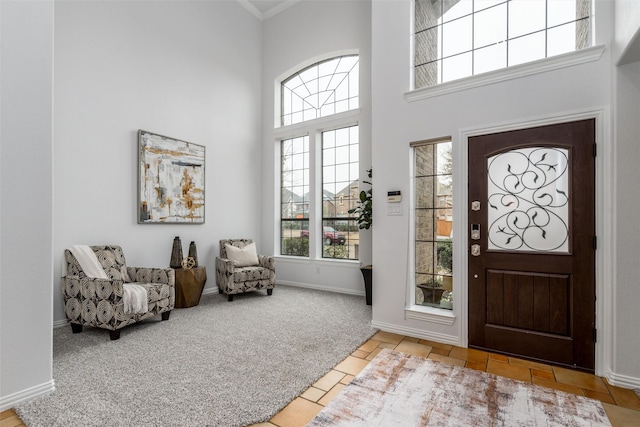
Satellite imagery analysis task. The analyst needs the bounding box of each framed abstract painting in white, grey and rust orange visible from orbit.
[138,130,205,224]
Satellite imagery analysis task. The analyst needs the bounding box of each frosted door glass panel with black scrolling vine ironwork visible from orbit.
[487,147,570,253]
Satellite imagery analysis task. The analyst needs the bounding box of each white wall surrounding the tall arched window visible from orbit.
[262,0,371,295]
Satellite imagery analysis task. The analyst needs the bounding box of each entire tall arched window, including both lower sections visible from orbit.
[280,55,360,259]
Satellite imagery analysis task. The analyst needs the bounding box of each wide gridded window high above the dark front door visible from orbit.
[414,0,591,89]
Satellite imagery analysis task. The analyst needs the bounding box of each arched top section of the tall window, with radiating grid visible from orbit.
[280,55,359,126]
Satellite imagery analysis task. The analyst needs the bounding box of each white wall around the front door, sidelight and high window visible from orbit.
[372,0,624,377]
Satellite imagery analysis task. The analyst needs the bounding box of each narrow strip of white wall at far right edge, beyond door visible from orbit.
[612,0,640,387]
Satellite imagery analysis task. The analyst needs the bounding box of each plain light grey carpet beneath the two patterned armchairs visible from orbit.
[16,286,377,427]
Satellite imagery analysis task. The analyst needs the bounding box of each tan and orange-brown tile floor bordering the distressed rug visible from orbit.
[250,332,640,427]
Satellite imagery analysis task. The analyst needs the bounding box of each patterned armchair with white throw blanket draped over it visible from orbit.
[62,246,175,340]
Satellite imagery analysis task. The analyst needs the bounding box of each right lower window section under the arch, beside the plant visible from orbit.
[322,126,360,259]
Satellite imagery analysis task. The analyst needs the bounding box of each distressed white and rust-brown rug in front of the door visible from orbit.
[307,349,611,427]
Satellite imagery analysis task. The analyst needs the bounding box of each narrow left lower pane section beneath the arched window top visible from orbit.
[280,136,310,256]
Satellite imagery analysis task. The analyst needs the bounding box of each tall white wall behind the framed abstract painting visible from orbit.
[53,1,270,322]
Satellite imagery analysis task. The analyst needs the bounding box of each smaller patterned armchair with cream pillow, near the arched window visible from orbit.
[216,239,276,301]
